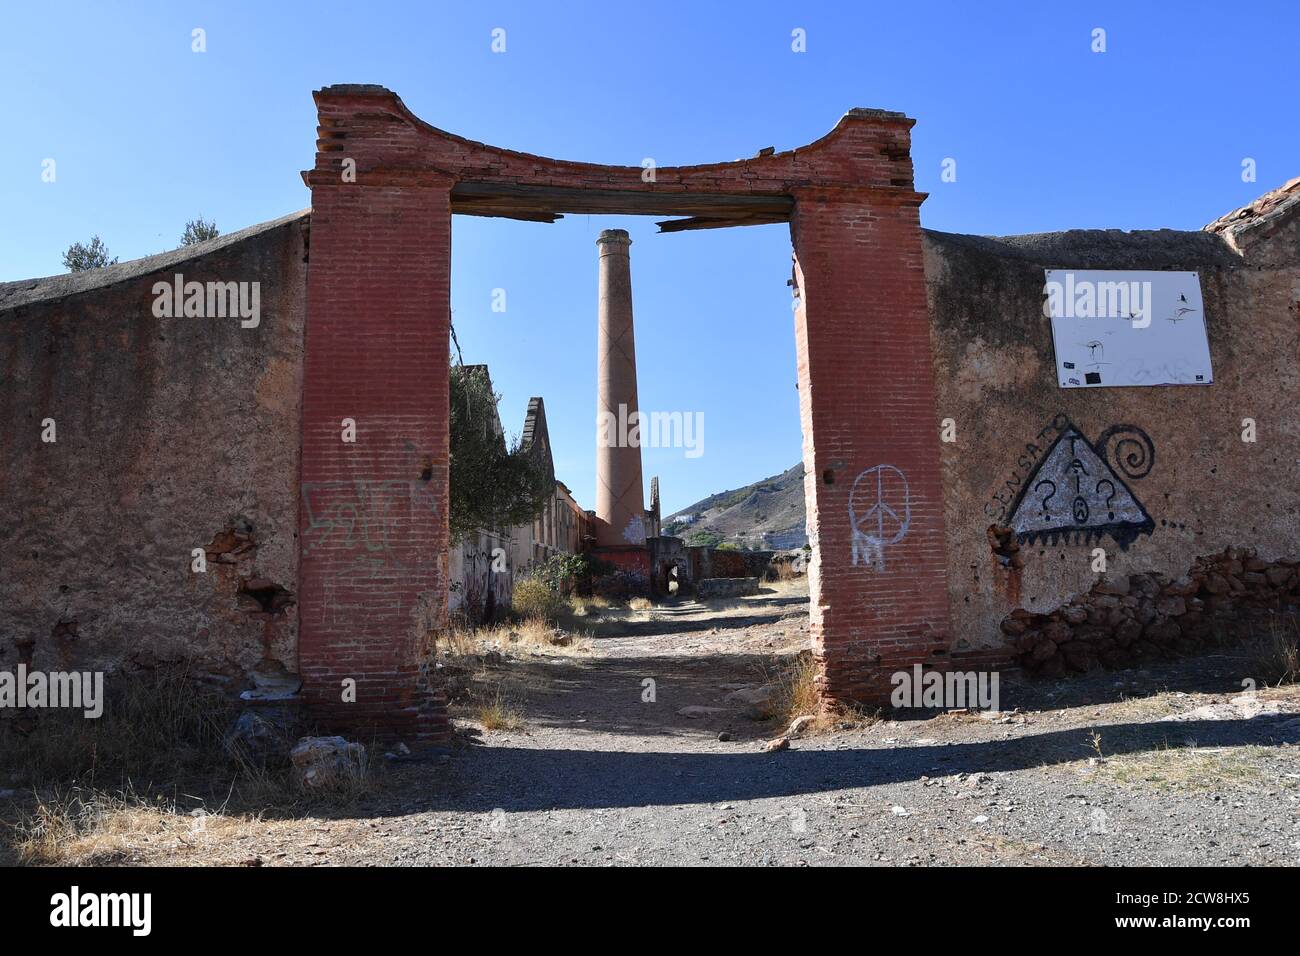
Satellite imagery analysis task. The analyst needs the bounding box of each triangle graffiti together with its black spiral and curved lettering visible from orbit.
[985,415,1156,550]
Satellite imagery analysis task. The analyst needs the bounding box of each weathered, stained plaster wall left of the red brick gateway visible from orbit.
[0,213,308,691]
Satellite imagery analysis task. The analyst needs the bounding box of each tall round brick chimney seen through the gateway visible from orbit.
[595,229,646,548]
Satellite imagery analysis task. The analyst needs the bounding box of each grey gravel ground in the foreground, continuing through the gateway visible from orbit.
[12,592,1300,866]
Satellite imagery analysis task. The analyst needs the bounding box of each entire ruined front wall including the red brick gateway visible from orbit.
[0,86,1300,737]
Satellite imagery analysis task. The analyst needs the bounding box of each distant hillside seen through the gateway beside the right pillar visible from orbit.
[663,463,809,550]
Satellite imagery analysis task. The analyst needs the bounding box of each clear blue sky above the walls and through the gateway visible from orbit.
[0,0,1300,512]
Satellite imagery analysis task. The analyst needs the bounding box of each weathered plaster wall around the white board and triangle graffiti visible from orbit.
[926,184,1300,661]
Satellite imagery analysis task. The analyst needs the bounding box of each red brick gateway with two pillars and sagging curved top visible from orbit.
[299,86,948,737]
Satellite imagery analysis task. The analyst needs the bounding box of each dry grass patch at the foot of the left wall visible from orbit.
[0,665,378,864]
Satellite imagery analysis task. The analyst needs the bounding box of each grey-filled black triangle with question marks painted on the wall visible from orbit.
[1010,424,1156,550]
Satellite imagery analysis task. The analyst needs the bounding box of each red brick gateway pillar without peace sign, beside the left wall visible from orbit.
[299,178,451,739]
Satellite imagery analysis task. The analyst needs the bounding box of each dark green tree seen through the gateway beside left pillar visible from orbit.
[447,365,555,542]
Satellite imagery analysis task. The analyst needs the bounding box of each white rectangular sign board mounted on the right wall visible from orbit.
[1043,269,1214,389]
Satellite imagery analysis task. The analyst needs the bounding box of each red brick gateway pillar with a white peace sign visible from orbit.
[790,189,948,704]
